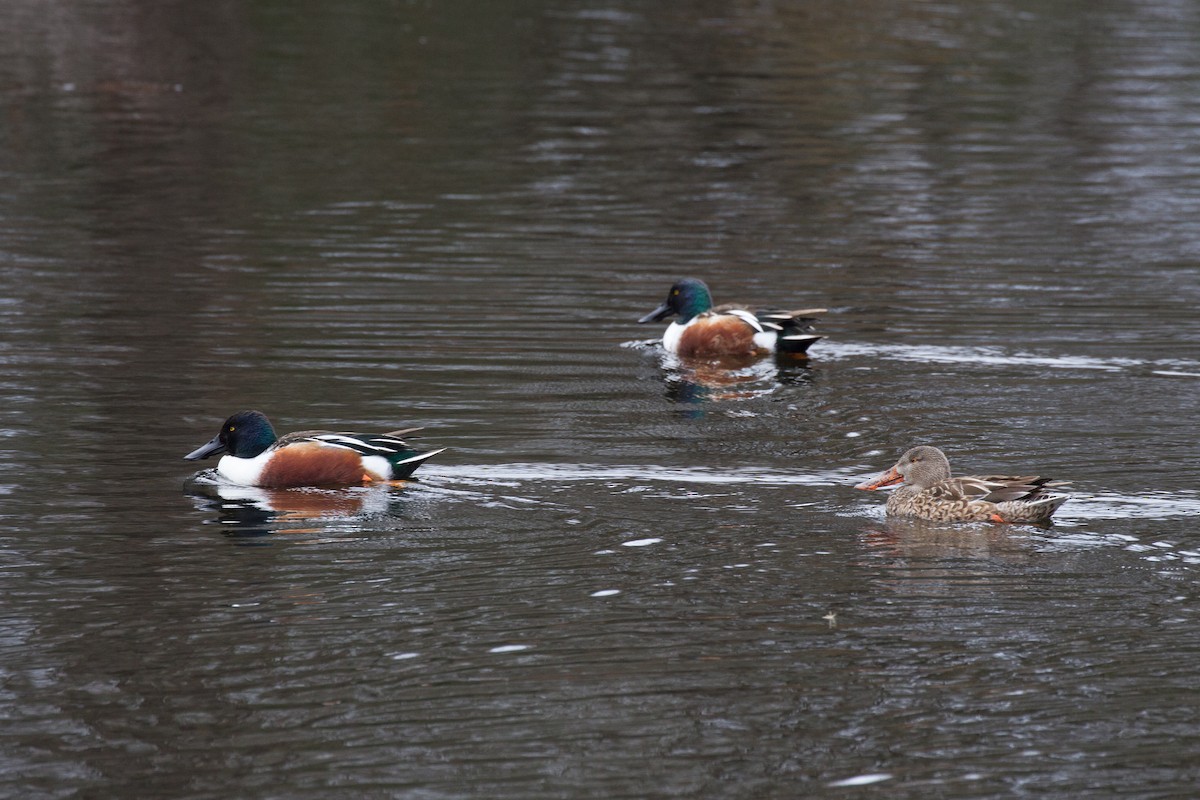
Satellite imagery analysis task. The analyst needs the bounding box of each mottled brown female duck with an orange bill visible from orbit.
[854,445,1067,522]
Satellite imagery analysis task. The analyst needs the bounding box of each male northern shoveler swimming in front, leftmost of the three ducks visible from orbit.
[184,411,445,489]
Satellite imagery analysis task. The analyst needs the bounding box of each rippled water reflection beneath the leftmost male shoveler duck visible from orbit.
[184,469,417,539]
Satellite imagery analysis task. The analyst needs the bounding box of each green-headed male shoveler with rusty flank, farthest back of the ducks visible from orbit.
[637,278,826,359]
